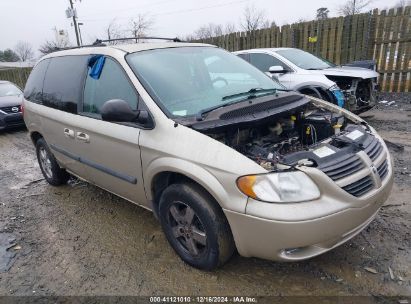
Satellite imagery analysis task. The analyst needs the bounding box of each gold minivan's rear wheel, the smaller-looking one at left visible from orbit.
[36,138,70,186]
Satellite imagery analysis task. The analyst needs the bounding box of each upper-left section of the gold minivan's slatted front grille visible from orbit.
[318,154,364,180]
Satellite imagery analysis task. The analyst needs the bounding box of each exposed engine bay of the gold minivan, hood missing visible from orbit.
[206,104,368,170]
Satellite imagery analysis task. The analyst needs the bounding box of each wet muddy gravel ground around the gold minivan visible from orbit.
[0,95,411,298]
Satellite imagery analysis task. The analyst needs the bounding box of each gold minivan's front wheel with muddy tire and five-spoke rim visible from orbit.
[159,183,235,270]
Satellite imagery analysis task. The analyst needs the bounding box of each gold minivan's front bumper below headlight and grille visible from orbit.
[224,150,393,261]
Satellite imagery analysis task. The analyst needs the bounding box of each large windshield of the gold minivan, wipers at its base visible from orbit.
[127,47,284,117]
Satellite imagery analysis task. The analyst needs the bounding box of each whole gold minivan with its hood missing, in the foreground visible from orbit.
[24,42,393,270]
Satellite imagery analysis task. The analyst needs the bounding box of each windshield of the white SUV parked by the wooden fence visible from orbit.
[276,49,335,70]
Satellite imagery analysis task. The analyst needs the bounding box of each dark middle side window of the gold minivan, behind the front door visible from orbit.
[43,56,88,114]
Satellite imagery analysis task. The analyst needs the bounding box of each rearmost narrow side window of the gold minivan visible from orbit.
[24,59,50,103]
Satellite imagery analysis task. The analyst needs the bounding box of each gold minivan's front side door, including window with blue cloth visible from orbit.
[75,57,146,205]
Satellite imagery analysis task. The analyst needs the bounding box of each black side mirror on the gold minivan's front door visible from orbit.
[100,99,139,122]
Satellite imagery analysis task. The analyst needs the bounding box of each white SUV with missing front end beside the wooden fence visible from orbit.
[235,48,378,113]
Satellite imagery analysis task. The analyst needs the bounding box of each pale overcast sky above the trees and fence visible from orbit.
[0,0,398,56]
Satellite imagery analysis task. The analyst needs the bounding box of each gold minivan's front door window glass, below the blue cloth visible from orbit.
[83,57,138,114]
